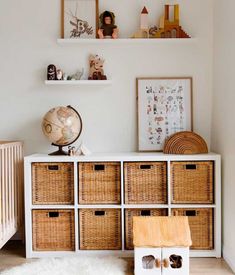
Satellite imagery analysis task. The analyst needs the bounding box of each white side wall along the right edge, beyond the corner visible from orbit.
[211,0,235,271]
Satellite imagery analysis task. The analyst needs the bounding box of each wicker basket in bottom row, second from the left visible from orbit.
[79,209,122,250]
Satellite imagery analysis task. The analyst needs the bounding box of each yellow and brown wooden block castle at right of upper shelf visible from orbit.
[150,4,190,38]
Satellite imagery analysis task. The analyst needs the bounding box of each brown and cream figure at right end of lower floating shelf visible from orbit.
[88,55,107,80]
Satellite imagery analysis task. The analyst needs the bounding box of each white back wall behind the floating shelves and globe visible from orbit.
[0,0,213,154]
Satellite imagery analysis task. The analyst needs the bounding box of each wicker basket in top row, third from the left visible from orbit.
[124,162,167,204]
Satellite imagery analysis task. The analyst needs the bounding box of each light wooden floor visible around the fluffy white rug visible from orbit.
[0,241,234,275]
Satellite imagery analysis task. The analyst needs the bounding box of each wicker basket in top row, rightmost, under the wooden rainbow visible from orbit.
[171,161,214,204]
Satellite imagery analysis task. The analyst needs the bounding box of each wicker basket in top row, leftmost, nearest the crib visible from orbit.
[32,162,74,205]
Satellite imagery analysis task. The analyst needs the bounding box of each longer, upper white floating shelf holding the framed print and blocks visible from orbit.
[57,38,196,45]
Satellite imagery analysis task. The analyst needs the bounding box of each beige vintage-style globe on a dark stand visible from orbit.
[42,106,82,155]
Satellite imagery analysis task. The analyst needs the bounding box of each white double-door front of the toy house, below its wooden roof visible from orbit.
[135,247,189,275]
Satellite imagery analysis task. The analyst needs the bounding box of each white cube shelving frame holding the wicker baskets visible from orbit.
[24,152,221,258]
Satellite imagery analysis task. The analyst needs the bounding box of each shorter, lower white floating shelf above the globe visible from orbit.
[45,80,112,86]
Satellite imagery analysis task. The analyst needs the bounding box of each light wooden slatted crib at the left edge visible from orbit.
[0,141,24,249]
